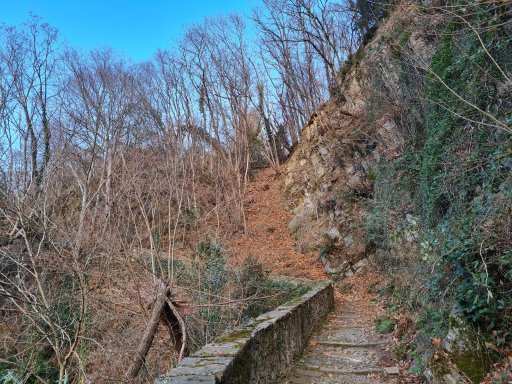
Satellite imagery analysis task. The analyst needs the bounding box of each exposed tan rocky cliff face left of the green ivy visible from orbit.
[283,5,435,278]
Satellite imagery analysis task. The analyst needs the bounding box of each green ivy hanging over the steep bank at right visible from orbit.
[366,1,512,356]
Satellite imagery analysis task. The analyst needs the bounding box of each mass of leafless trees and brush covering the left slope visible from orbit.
[0,0,374,383]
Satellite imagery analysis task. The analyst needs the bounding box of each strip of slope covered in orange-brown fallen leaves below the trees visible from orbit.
[227,168,326,279]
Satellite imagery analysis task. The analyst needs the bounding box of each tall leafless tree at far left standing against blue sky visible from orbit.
[0,17,58,188]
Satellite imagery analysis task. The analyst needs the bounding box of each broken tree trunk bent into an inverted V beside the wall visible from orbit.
[126,282,187,379]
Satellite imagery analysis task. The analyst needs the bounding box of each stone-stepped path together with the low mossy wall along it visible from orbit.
[155,282,400,384]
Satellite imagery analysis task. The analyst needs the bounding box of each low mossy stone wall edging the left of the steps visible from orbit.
[155,282,334,384]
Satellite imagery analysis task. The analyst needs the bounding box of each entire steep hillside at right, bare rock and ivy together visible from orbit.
[283,2,512,383]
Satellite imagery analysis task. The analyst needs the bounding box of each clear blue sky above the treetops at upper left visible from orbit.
[0,0,258,61]
